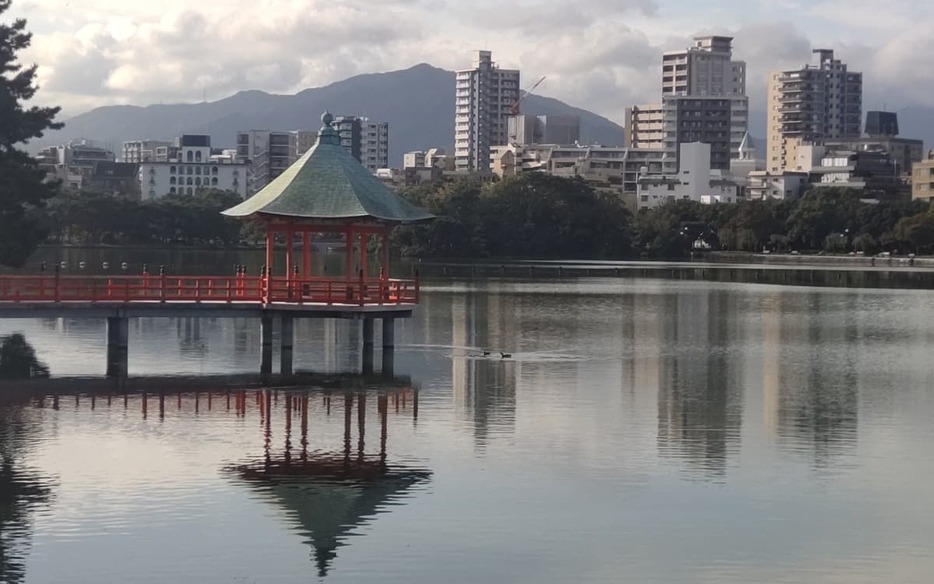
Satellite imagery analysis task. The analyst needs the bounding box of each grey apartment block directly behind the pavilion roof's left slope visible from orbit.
[237,130,318,194]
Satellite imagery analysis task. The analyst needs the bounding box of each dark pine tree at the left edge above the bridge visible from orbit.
[0,0,62,266]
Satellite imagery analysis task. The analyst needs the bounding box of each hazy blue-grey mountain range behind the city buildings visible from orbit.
[38,64,623,166]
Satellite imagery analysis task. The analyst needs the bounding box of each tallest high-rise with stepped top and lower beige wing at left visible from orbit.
[625,36,749,173]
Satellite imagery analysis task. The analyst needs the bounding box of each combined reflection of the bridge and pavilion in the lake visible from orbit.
[10,374,431,577]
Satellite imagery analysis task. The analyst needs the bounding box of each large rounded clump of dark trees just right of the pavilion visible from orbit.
[395,173,632,258]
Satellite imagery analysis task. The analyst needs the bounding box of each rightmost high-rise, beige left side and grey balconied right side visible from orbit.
[766,49,863,173]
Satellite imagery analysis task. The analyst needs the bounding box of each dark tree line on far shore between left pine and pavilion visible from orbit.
[48,190,244,245]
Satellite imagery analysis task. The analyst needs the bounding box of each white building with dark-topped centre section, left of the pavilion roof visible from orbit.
[139,134,251,201]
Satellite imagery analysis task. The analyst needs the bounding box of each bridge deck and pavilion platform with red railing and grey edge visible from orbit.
[0,275,419,318]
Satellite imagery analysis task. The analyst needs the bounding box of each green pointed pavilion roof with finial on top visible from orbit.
[223,113,434,223]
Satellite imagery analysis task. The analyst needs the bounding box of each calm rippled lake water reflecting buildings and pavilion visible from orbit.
[0,279,934,584]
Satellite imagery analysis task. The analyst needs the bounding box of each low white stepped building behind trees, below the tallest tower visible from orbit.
[636,142,740,209]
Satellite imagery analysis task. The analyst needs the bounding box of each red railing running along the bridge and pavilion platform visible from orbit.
[0,275,419,306]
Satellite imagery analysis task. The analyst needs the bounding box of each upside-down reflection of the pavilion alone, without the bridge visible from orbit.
[230,388,431,577]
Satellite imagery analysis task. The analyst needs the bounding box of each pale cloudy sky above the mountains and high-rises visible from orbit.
[7,0,934,123]
